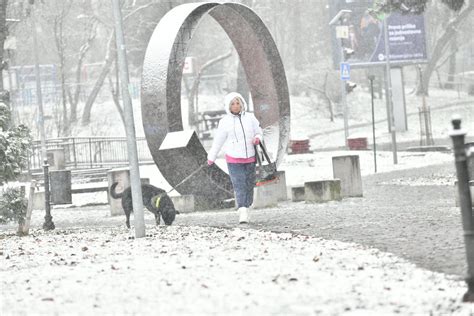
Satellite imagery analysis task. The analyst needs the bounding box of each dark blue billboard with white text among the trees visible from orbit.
[329,0,428,67]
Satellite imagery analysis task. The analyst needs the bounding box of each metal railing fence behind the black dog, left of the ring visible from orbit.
[29,137,153,170]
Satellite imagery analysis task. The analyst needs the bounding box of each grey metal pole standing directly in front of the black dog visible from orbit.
[112,0,145,238]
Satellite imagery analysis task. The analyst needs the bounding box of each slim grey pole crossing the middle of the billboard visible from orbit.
[383,15,398,165]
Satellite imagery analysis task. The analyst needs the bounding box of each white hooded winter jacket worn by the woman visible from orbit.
[207,92,263,161]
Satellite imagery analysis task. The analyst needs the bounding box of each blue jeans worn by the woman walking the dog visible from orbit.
[227,162,255,207]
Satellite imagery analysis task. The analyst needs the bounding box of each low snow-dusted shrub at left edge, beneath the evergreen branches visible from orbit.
[0,187,28,224]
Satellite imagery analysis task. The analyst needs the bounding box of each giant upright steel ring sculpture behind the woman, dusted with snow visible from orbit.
[141,2,290,200]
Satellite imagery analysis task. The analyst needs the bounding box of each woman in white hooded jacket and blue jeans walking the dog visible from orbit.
[207,92,263,223]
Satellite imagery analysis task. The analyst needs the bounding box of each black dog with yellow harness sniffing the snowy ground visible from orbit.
[110,182,178,228]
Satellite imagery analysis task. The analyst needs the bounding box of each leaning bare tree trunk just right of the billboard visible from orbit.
[416,1,474,95]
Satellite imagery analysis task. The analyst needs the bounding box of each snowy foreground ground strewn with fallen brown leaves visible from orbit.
[0,223,474,315]
